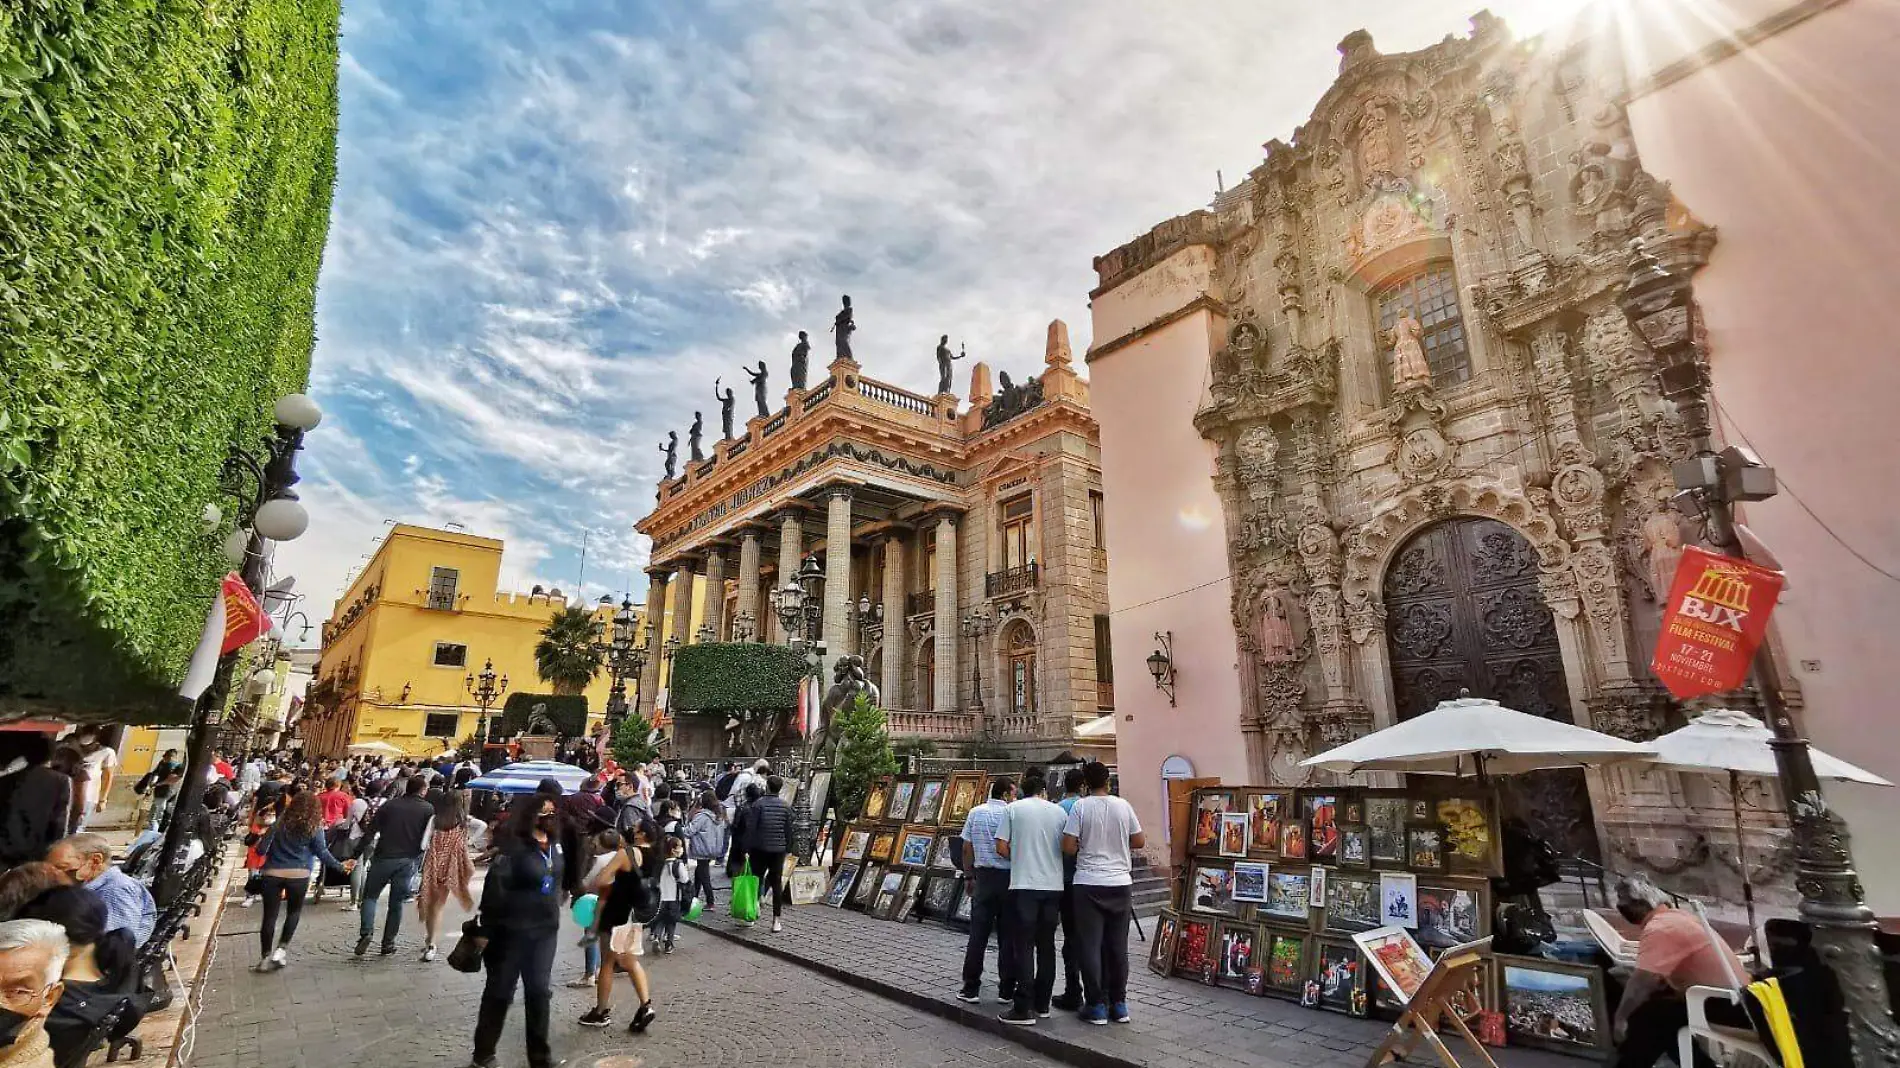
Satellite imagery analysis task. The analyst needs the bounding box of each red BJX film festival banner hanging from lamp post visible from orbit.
[1649,545,1782,699]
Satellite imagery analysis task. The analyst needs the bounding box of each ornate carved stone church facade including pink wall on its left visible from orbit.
[1087,15,1792,915]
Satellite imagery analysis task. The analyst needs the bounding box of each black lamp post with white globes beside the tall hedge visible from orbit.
[154,393,323,905]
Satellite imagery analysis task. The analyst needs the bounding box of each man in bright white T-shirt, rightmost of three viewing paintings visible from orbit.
[1062,760,1148,1024]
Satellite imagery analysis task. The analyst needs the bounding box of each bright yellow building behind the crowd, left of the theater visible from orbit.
[300,524,646,756]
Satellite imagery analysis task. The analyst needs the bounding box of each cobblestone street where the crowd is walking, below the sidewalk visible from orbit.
[204,877,1058,1068]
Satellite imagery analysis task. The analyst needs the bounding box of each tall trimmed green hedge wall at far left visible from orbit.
[0,0,338,713]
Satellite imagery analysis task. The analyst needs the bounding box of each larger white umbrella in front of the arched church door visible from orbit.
[1300,697,1655,777]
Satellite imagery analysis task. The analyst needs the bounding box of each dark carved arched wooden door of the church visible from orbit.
[1385,517,1600,861]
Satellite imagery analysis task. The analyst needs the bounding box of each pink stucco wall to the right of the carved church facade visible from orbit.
[1630,0,1900,914]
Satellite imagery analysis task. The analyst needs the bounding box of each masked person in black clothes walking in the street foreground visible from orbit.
[469,792,562,1068]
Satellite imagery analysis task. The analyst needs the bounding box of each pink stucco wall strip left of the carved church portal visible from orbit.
[1089,247,1246,855]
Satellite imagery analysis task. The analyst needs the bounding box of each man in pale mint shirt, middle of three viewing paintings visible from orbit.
[996,768,1068,1026]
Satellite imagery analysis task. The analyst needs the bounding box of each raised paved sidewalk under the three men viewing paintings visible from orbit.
[701,905,1579,1068]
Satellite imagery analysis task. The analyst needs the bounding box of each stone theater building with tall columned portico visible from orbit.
[637,321,1113,758]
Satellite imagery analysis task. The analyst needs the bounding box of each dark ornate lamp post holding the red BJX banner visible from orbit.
[1621,239,1900,1064]
